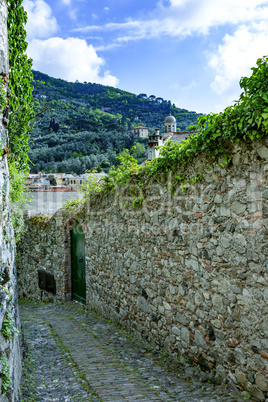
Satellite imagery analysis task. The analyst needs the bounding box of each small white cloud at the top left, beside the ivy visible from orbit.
[23,0,58,40]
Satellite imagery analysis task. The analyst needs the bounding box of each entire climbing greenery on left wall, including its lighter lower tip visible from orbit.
[7,0,34,240]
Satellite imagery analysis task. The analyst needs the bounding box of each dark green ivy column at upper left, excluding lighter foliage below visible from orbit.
[7,0,34,172]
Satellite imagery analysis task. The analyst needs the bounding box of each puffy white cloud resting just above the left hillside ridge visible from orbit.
[28,37,118,87]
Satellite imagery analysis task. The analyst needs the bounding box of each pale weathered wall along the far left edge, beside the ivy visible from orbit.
[0,0,22,401]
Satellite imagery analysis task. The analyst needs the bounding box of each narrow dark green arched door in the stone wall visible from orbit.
[72,222,86,304]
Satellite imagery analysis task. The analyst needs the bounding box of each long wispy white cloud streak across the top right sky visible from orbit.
[73,0,268,42]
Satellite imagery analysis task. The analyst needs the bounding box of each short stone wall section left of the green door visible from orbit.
[17,213,73,301]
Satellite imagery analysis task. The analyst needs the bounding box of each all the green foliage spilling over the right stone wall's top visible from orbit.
[68,56,268,212]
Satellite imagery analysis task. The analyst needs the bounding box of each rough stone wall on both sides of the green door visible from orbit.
[18,140,268,401]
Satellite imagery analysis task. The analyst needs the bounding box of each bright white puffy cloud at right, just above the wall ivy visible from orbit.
[209,21,268,98]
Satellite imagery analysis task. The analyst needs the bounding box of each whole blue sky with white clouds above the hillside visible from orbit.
[23,0,268,113]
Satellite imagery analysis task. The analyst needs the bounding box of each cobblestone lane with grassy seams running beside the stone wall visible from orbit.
[20,302,249,402]
